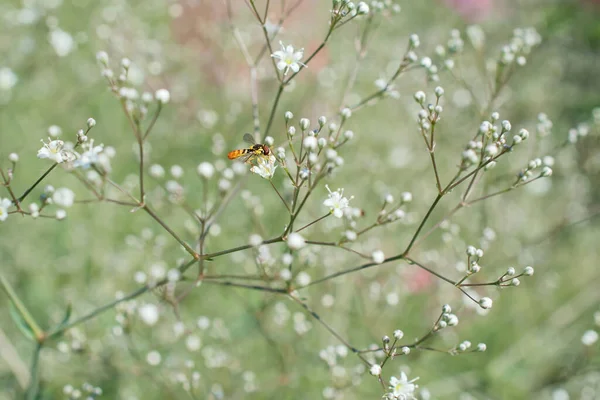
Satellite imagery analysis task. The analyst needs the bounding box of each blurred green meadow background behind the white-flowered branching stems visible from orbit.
[0,0,600,399]
